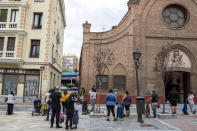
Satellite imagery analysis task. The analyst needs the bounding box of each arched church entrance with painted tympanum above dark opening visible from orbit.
[165,49,191,103]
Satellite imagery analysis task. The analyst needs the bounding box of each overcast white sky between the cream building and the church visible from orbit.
[64,0,129,57]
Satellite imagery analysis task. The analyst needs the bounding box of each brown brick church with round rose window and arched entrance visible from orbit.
[80,0,197,103]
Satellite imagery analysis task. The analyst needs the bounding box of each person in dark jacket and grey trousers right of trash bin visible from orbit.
[150,89,158,118]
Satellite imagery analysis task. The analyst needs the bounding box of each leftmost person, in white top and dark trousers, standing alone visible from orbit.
[7,91,15,115]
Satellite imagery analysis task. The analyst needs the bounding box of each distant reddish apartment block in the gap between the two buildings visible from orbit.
[62,56,79,72]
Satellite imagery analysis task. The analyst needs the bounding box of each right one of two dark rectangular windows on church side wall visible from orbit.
[114,75,126,90]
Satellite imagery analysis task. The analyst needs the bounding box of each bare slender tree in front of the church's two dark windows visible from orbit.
[94,45,113,113]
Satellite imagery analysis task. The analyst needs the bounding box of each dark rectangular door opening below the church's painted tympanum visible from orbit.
[165,71,190,103]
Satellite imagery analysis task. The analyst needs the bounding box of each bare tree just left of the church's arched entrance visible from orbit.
[154,42,173,113]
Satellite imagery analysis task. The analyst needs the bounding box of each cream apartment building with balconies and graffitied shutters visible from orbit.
[0,0,66,102]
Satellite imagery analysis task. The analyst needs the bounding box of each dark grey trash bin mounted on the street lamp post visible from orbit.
[136,96,145,114]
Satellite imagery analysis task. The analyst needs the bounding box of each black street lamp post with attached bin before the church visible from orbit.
[133,49,145,123]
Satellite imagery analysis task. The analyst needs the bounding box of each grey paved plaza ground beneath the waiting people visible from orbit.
[0,105,197,131]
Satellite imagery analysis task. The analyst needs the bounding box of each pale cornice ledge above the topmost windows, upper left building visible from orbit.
[0,2,29,7]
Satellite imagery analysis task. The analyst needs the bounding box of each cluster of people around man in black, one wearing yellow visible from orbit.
[45,86,77,129]
